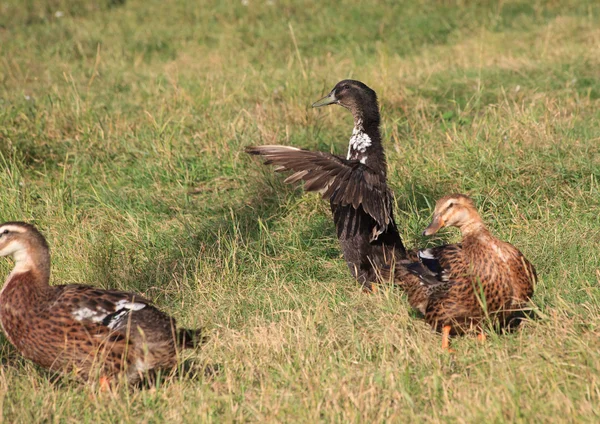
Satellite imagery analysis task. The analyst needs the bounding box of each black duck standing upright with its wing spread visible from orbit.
[246,80,406,291]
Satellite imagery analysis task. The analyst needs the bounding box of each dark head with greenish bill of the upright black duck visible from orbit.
[312,80,379,124]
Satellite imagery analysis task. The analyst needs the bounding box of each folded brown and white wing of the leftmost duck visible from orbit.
[56,285,152,330]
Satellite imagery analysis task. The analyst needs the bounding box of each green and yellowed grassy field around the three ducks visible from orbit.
[0,0,600,423]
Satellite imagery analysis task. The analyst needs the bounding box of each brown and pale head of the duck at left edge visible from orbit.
[0,222,50,269]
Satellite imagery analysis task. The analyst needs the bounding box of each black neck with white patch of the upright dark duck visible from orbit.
[348,111,386,174]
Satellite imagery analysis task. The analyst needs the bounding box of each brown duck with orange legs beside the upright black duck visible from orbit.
[394,194,537,351]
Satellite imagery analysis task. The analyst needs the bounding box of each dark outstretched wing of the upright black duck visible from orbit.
[246,145,393,232]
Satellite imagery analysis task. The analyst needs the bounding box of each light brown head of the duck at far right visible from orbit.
[423,194,482,236]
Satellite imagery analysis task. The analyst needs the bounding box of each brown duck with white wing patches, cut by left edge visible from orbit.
[0,222,201,389]
